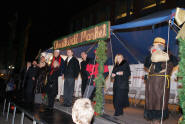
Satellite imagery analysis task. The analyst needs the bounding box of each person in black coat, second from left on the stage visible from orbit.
[24,60,38,104]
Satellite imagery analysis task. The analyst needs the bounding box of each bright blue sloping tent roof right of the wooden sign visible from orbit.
[111,9,175,30]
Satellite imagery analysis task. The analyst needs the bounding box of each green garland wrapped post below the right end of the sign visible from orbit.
[94,40,107,115]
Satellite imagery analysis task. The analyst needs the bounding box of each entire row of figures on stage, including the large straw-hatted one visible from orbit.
[19,37,178,124]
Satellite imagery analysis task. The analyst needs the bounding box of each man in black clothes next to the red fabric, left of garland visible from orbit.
[80,52,90,96]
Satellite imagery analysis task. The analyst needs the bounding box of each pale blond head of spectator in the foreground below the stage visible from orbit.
[72,98,94,124]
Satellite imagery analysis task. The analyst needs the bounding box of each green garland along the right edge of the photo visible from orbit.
[178,38,185,124]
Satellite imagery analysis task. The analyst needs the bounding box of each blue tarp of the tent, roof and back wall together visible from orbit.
[46,10,178,64]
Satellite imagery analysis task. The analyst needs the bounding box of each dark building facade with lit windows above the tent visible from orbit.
[69,0,185,33]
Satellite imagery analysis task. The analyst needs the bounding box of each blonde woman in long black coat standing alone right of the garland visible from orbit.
[111,54,131,116]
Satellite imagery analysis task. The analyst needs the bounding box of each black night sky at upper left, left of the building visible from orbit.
[1,0,97,61]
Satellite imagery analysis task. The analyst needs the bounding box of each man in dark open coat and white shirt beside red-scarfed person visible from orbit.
[63,49,80,107]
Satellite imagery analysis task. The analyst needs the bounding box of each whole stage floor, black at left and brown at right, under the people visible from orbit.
[0,96,181,124]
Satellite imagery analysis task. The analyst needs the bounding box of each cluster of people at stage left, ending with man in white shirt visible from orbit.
[21,49,80,108]
